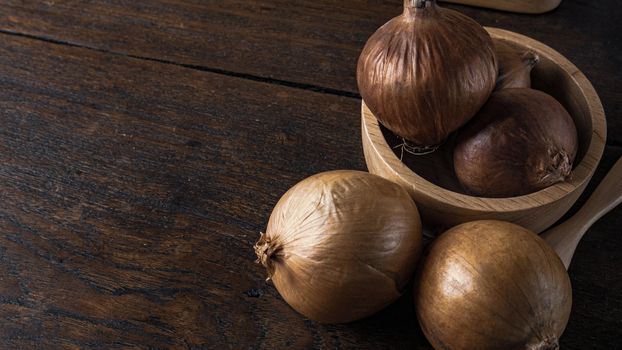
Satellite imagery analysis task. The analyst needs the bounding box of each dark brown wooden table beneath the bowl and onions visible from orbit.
[0,0,622,349]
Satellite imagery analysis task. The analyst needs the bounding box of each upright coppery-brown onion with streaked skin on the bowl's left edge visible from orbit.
[357,0,497,146]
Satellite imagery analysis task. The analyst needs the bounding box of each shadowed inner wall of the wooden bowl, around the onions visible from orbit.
[380,38,593,195]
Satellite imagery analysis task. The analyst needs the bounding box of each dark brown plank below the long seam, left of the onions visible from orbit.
[0,35,425,349]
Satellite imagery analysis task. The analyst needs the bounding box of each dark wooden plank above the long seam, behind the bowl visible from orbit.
[0,0,622,145]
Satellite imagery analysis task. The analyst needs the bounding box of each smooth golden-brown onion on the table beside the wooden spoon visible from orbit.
[414,220,572,350]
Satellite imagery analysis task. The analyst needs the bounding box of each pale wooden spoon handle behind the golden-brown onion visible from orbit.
[541,158,622,270]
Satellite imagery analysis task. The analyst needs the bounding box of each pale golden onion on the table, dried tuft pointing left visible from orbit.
[255,170,422,323]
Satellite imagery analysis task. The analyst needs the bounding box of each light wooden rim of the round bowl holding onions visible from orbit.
[361,27,607,212]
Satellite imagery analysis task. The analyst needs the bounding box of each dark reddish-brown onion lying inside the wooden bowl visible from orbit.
[454,89,578,197]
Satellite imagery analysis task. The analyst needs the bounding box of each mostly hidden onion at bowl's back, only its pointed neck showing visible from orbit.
[495,40,540,90]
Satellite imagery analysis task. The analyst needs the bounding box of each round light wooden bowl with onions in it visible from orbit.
[361,28,607,233]
